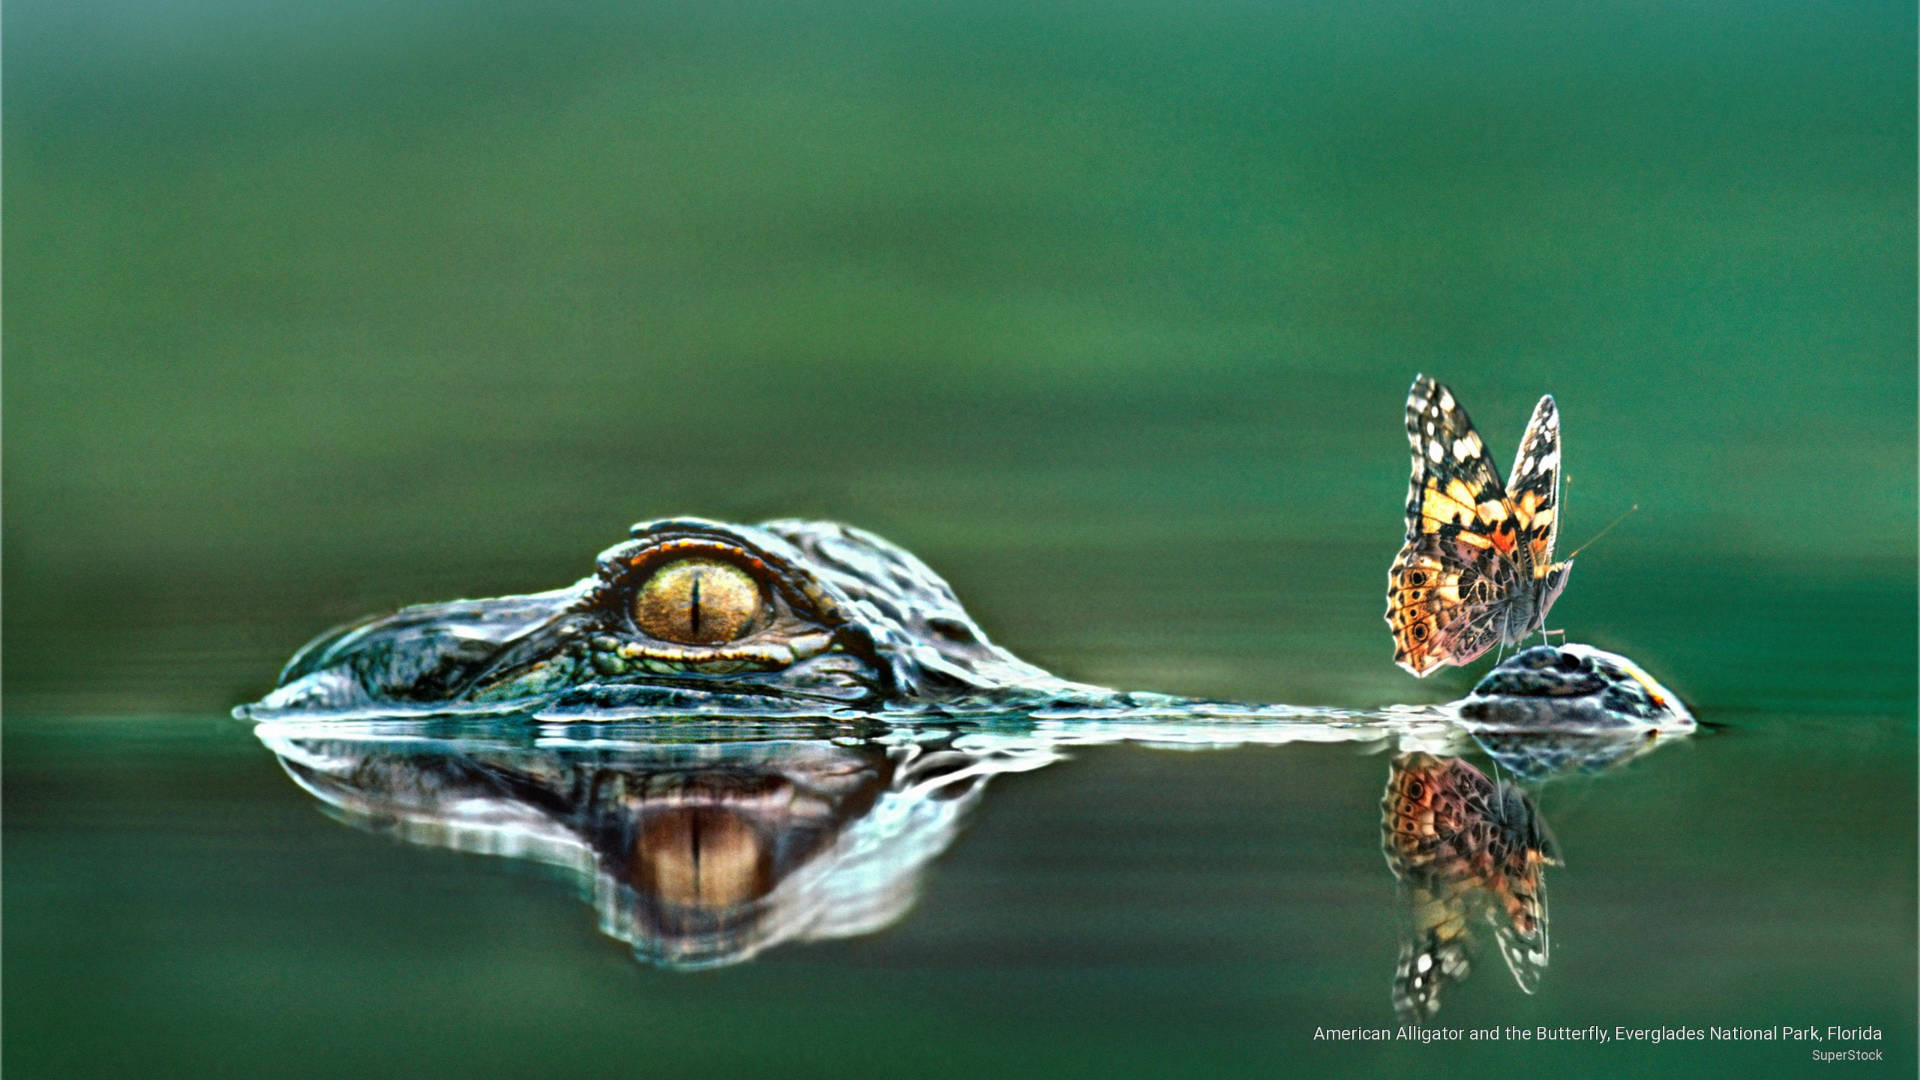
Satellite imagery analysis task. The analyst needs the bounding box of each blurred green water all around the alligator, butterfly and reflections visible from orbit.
[0,0,1920,1076]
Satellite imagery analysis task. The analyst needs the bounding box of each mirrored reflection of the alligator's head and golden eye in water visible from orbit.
[259,724,981,969]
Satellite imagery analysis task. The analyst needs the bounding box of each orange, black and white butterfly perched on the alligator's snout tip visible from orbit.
[1386,375,1572,675]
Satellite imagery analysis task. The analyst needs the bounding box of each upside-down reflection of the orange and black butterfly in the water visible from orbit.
[1380,753,1559,1022]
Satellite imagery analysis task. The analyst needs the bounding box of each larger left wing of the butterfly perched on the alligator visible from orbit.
[1386,375,1520,676]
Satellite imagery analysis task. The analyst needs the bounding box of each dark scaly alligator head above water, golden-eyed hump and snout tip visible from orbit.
[236,519,1693,730]
